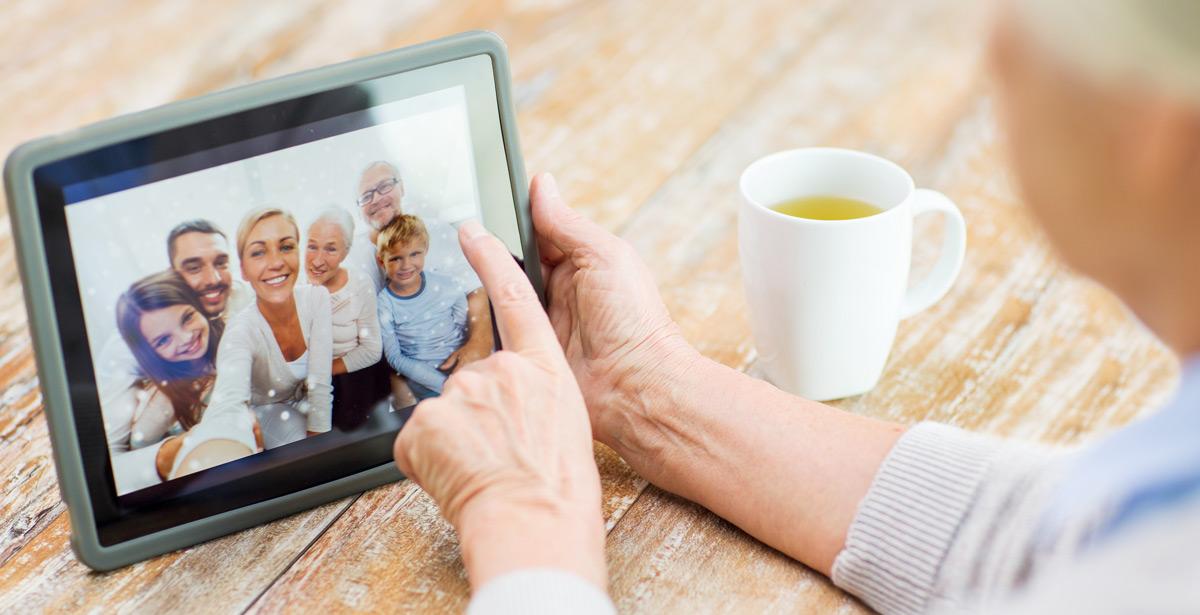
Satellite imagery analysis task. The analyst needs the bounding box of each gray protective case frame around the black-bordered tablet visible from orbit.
[4,31,542,571]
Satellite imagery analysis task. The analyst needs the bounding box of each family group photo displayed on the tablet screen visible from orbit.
[70,88,494,494]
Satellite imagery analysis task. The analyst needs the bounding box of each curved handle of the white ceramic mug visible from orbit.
[900,189,967,318]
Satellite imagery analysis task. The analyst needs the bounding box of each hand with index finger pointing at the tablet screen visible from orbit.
[395,222,607,589]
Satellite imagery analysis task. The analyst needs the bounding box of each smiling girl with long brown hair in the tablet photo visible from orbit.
[101,271,224,494]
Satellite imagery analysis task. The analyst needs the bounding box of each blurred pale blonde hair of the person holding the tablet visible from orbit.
[1012,0,1200,106]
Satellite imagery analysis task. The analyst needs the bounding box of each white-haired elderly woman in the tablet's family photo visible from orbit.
[305,208,389,429]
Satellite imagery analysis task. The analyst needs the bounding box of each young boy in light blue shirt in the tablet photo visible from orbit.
[376,214,467,400]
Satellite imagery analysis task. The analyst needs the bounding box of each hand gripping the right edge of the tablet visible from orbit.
[529,173,701,459]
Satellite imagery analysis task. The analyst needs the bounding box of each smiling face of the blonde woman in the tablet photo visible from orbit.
[241,215,300,303]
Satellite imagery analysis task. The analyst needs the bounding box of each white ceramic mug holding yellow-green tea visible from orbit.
[738,148,966,400]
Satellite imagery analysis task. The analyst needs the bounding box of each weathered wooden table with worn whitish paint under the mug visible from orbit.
[0,0,1177,613]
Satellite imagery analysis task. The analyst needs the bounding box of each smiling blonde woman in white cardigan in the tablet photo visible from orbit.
[201,208,334,448]
